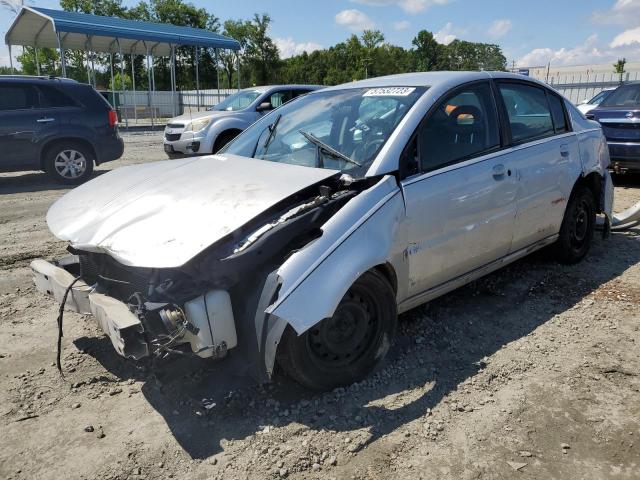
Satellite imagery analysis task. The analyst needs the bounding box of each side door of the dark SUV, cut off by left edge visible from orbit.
[0,82,43,168]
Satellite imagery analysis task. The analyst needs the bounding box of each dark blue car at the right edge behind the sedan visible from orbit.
[587,82,640,173]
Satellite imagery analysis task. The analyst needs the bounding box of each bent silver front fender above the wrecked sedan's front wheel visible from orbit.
[266,175,406,334]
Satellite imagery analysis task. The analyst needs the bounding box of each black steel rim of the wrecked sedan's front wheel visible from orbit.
[307,291,381,370]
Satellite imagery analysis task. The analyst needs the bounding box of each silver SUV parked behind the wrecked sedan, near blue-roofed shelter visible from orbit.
[164,85,321,157]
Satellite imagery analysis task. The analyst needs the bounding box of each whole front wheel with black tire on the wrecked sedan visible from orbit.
[277,271,397,391]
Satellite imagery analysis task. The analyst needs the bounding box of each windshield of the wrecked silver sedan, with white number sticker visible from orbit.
[223,87,426,177]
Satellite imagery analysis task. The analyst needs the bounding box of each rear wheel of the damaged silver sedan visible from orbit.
[555,186,596,264]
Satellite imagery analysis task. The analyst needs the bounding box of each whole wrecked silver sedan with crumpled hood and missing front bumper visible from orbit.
[32,72,613,389]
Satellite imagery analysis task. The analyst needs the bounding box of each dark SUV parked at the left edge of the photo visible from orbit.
[0,76,124,184]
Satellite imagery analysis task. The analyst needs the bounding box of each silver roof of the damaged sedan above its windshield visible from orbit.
[328,71,549,90]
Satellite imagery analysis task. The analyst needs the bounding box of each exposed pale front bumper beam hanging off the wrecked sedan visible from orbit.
[31,259,149,360]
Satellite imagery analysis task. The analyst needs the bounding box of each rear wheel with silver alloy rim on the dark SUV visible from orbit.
[44,142,93,185]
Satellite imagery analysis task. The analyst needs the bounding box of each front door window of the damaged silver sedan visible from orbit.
[409,83,500,173]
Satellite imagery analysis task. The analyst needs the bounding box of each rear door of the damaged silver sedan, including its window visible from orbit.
[497,81,580,252]
